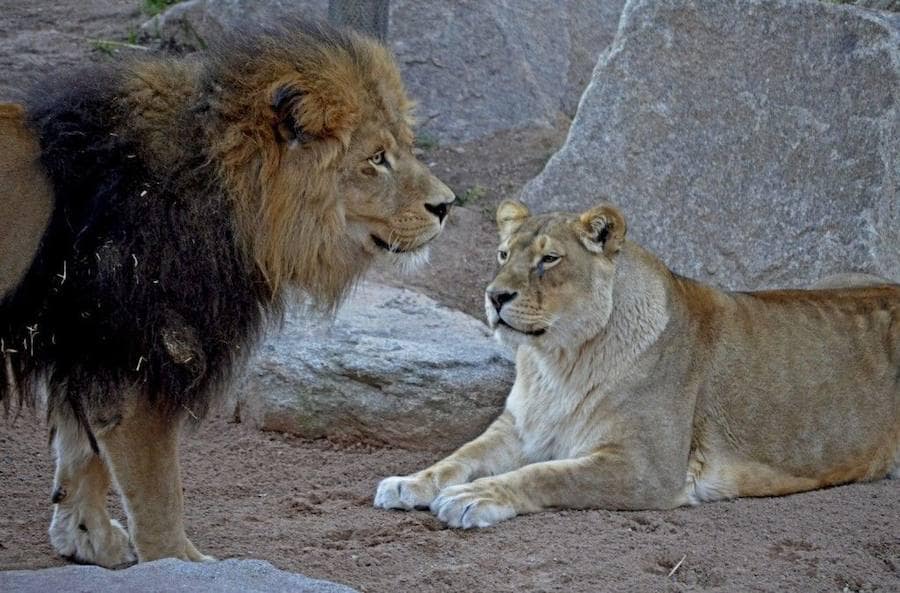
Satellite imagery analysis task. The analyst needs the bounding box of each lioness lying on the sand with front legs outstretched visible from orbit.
[375,202,900,528]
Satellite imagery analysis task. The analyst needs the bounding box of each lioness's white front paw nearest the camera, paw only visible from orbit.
[431,480,516,529]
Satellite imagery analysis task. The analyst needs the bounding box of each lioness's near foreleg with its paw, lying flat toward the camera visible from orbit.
[431,449,678,529]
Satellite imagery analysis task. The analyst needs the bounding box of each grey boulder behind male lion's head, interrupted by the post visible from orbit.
[143,0,624,143]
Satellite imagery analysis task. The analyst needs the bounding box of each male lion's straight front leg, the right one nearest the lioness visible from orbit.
[97,400,213,562]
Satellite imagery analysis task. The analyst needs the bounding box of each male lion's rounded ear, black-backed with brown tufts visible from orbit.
[271,80,359,144]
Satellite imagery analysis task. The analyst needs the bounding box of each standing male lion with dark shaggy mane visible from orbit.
[0,22,454,566]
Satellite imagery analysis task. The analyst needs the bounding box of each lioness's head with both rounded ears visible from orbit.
[484,201,625,346]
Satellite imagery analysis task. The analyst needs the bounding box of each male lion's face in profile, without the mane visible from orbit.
[339,119,454,261]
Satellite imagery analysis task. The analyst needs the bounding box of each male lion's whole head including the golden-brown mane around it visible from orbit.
[211,31,454,307]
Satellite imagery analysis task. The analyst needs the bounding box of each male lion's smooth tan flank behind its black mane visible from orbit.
[0,103,53,300]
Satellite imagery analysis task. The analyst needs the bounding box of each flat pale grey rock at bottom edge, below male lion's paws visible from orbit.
[0,559,356,593]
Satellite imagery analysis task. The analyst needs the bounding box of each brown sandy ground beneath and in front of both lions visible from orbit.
[0,417,900,593]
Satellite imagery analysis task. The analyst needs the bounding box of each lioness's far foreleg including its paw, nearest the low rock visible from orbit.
[375,412,525,510]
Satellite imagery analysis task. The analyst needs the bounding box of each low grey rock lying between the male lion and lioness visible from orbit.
[232,284,514,449]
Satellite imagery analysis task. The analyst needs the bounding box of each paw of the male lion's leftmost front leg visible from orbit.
[49,509,137,568]
